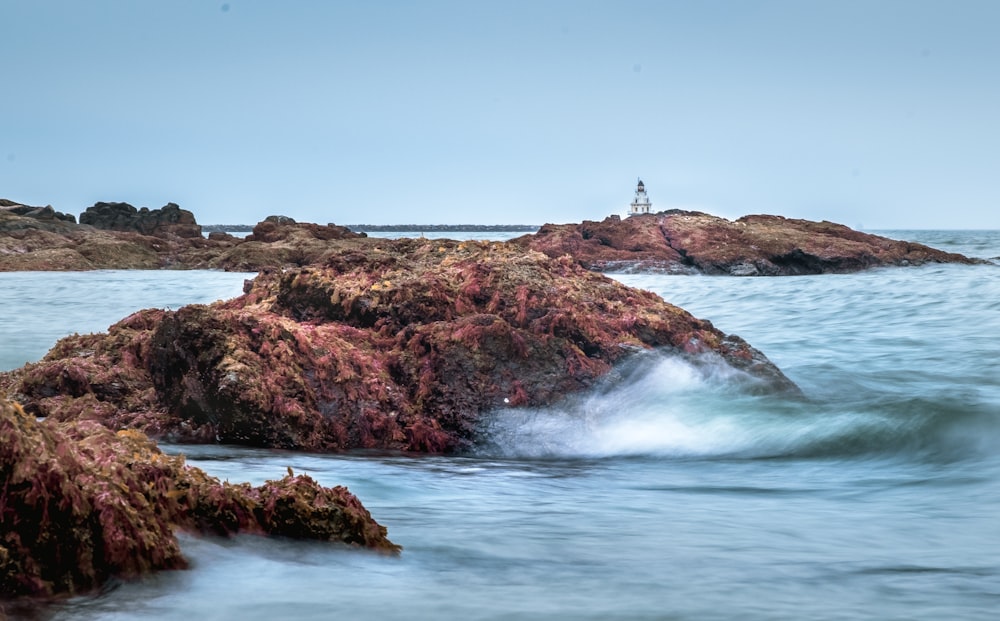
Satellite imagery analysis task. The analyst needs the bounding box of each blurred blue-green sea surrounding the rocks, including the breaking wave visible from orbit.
[0,231,1000,621]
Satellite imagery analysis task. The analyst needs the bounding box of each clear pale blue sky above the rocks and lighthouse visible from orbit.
[0,0,1000,229]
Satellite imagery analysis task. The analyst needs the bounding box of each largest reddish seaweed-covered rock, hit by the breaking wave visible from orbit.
[0,239,796,452]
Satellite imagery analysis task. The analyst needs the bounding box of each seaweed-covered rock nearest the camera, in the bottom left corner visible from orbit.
[0,400,398,598]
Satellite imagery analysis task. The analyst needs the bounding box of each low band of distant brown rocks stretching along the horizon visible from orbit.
[0,200,985,276]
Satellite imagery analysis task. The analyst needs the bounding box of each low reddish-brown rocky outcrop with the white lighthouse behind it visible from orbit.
[514,210,978,276]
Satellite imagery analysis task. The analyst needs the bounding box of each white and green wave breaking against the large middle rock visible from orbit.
[477,354,1000,459]
